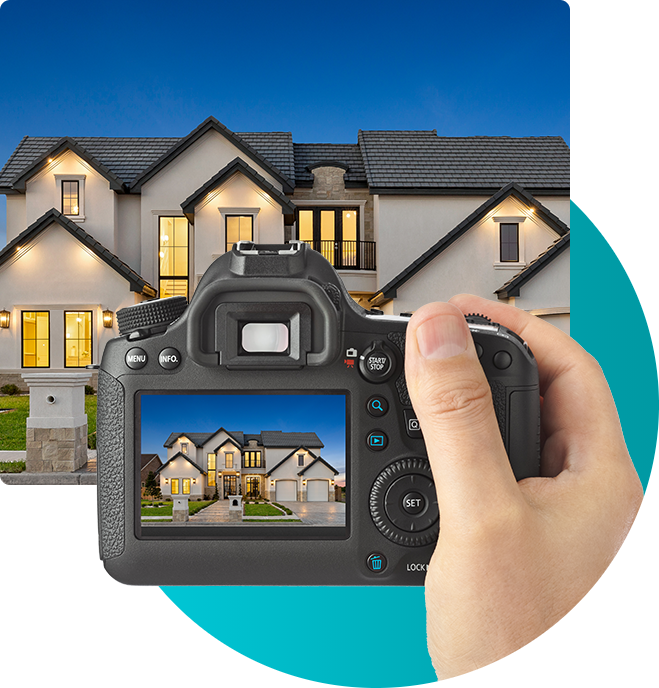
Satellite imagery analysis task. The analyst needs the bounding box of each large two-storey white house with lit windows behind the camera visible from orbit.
[0,117,570,388]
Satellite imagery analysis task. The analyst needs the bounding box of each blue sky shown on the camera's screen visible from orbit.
[141,394,346,474]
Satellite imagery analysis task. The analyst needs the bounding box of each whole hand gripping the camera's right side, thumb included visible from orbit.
[405,295,643,680]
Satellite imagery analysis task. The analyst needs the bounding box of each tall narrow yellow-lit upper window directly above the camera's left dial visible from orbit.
[158,217,189,299]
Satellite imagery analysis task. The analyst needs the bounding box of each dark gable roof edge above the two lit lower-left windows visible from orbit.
[0,208,156,297]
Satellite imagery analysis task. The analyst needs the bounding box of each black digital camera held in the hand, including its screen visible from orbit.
[97,242,540,585]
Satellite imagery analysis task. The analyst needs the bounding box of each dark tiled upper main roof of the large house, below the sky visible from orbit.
[0,117,570,194]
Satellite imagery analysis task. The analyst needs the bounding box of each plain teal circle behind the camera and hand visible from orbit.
[161,203,659,688]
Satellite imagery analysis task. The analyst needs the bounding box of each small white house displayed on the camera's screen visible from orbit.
[157,428,339,502]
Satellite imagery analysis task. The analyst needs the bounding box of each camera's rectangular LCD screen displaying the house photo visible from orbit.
[136,393,348,538]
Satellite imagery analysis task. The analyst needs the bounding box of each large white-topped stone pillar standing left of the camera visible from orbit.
[22,372,91,473]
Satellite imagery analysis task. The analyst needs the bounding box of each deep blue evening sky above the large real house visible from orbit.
[0,0,570,246]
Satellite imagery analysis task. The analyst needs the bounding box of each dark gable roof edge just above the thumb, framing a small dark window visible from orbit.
[369,182,570,304]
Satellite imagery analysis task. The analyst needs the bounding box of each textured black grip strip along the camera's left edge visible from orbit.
[96,369,125,561]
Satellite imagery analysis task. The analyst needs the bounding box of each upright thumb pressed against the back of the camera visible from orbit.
[405,303,519,517]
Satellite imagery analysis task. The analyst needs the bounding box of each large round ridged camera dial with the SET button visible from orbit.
[369,458,439,547]
